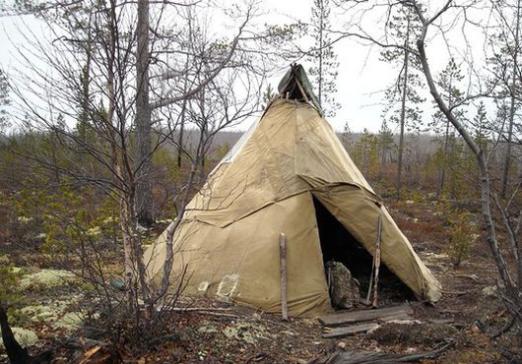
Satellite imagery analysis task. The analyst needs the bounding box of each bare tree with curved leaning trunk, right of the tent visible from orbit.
[343,0,522,333]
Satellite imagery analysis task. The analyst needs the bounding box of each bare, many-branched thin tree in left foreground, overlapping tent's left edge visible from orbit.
[6,0,268,337]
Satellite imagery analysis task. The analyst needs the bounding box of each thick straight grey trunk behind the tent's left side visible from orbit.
[136,0,154,226]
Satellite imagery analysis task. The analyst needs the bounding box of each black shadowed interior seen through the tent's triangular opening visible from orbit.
[313,196,415,305]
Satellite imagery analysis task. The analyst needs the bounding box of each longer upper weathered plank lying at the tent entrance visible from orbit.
[319,304,413,326]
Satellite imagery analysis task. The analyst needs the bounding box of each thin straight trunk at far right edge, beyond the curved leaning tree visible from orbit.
[501,0,520,198]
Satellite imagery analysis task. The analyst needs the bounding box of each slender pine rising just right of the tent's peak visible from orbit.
[308,0,340,117]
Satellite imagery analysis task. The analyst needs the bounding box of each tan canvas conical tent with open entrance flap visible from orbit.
[145,66,440,316]
